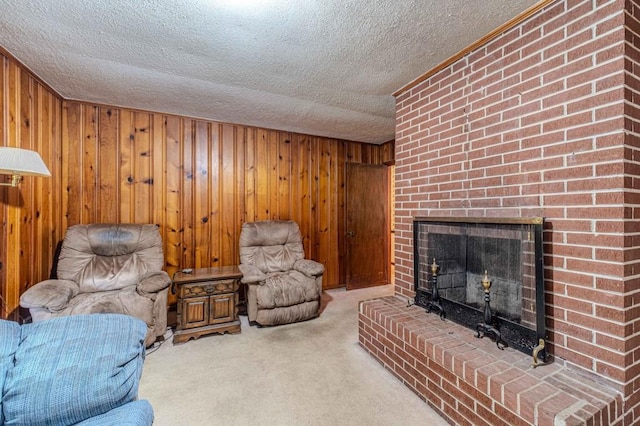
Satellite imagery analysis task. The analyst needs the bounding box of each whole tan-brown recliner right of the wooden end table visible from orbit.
[239,220,324,325]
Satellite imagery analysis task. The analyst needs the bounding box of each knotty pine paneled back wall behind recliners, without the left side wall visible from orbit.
[61,101,393,300]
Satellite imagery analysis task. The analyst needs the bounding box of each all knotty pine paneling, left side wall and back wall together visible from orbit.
[0,48,394,319]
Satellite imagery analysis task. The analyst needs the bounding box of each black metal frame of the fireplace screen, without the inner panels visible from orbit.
[413,217,547,367]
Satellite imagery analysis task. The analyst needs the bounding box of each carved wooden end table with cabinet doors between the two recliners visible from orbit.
[172,266,242,344]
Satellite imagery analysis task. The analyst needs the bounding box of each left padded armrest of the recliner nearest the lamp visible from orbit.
[20,280,80,312]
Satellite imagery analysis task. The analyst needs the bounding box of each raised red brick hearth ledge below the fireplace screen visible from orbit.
[359,296,622,426]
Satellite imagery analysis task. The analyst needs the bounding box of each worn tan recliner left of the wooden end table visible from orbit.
[20,224,171,346]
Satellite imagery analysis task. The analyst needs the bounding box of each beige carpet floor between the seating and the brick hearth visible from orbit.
[139,285,448,426]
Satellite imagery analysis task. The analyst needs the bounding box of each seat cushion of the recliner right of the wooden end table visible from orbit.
[256,271,320,309]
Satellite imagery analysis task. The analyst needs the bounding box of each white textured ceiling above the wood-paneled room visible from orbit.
[0,0,536,143]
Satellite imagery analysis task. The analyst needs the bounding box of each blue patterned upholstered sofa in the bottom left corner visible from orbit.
[0,314,153,426]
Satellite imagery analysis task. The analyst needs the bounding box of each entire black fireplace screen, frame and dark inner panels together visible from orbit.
[413,218,546,360]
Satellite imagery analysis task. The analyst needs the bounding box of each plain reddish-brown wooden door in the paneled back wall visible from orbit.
[345,163,389,290]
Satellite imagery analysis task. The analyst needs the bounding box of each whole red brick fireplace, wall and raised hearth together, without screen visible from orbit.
[360,0,640,425]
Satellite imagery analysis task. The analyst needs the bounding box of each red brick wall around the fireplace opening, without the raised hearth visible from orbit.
[395,0,640,419]
